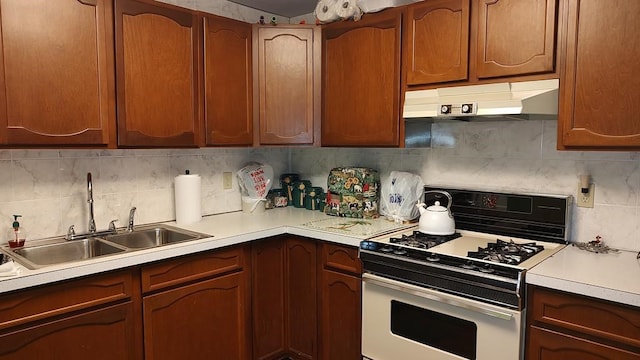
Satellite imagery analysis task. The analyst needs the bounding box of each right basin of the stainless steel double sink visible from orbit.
[104,225,209,249]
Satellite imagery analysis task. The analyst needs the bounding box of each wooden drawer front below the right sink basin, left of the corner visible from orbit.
[142,247,248,292]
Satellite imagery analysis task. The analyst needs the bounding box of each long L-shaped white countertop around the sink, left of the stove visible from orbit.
[0,207,408,293]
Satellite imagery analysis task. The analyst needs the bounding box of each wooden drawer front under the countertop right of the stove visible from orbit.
[529,287,640,347]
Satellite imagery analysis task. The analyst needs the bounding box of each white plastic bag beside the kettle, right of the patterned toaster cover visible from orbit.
[380,171,424,222]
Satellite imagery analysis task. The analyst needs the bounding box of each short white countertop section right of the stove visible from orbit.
[526,245,640,307]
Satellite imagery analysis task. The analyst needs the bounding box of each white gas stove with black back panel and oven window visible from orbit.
[360,187,571,360]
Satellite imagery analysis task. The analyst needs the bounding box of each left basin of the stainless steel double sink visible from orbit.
[5,238,127,269]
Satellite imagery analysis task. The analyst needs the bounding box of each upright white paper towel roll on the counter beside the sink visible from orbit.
[175,174,202,225]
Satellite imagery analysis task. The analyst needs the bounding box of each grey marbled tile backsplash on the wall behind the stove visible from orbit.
[291,120,640,250]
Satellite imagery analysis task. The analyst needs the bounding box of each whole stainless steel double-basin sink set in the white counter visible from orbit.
[2,225,210,269]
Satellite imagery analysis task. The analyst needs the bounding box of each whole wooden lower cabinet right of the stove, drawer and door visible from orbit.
[526,286,640,360]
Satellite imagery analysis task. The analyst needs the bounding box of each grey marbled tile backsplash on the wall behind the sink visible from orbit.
[0,148,289,239]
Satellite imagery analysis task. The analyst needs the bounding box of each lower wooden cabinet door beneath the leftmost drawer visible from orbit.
[0,302,142,360]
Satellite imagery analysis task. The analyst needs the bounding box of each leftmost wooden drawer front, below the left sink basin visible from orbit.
[0,271,133,329]
